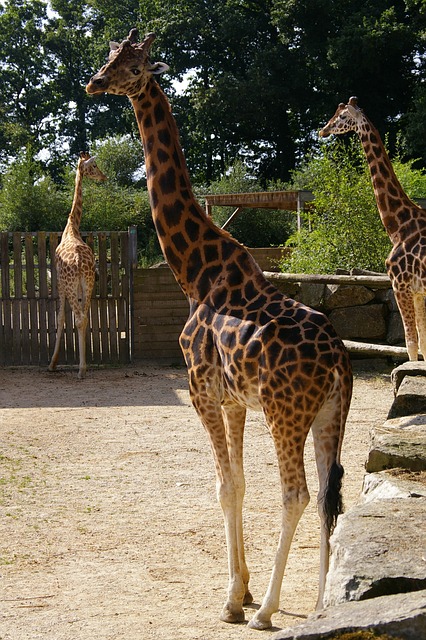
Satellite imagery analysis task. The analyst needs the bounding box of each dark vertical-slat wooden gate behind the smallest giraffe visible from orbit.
[0,227,136,366]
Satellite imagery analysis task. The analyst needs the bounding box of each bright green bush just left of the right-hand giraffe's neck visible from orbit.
[281,138,391,273]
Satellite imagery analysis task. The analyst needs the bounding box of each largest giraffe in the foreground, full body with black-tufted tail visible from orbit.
[86,30,352,629]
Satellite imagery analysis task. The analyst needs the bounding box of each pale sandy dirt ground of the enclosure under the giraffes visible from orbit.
[0,363,393,640]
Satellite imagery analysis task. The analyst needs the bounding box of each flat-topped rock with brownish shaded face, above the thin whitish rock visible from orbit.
[366,414,426,473]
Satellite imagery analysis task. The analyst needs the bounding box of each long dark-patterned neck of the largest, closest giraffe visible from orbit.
[131,78,263,301]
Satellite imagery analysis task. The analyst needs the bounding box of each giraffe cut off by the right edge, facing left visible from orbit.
[319,98,426,360]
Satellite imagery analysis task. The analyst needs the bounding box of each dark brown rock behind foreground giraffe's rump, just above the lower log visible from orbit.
[329,304,387,340]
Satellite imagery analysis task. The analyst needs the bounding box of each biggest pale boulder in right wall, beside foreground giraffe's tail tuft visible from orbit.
[324,497,426,607]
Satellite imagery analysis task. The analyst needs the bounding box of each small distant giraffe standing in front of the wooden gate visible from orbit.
[49,151,106,378]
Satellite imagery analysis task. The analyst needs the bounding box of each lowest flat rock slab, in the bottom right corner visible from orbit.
[273,590,426,640]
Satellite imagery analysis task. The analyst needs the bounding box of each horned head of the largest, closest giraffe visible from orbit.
[86,29,169,98]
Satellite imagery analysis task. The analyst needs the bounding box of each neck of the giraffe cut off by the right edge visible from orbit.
[358,116,419,243]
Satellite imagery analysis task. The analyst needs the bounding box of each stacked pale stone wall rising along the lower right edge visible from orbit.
[275,362,426,640]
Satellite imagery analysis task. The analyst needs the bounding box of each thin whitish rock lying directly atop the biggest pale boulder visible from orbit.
[361,469,426,502]
